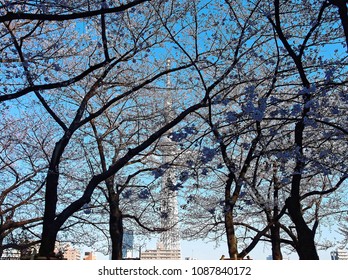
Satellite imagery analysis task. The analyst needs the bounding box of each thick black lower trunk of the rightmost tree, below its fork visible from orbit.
[286,197,319,260]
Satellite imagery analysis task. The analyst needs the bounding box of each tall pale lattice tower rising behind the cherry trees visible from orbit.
[160,59,180,253]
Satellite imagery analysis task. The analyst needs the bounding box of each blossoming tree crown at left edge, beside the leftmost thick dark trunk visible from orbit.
[0,106,54,257]
